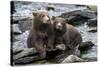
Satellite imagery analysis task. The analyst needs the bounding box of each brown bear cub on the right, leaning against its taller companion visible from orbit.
[52,17,82,55]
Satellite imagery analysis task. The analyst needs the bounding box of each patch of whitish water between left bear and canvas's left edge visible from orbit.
[12,31,29,49]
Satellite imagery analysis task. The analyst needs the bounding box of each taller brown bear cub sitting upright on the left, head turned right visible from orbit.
[27,10,54,58]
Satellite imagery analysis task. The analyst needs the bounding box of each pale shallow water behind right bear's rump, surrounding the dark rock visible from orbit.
[76,23,97,61]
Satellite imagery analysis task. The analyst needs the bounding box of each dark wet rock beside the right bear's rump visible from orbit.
[79,41,94,51]
